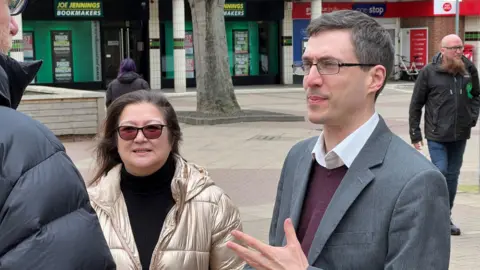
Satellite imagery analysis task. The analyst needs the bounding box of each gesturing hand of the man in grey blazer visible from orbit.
[227,219,308,270]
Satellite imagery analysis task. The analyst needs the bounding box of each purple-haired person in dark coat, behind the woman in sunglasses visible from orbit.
[105,58,150,108]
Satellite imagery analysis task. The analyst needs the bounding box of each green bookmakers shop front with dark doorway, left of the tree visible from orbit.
[23,0,149,90]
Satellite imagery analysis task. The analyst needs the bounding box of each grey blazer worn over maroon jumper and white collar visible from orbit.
[248,118,450,270]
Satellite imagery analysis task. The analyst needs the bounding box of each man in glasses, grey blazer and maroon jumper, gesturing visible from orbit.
[227,11,450,270]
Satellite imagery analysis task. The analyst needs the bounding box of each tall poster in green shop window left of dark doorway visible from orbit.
[50,30,73,83]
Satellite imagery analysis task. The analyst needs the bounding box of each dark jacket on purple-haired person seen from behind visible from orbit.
[105,72,150,107]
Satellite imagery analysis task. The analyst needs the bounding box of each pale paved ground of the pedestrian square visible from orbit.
[65,84,480,270]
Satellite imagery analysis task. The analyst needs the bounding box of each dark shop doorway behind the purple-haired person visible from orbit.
[102,21,148,88]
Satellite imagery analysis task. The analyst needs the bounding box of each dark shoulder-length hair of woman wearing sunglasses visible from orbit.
[92,90,182,183]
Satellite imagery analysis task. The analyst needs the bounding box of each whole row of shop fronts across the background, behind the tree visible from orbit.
[11,0,480,92]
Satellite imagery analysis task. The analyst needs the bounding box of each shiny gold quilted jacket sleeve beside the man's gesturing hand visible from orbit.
[210,194,245,270]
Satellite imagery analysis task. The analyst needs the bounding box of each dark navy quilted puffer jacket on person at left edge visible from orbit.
[0,55,116,270]
